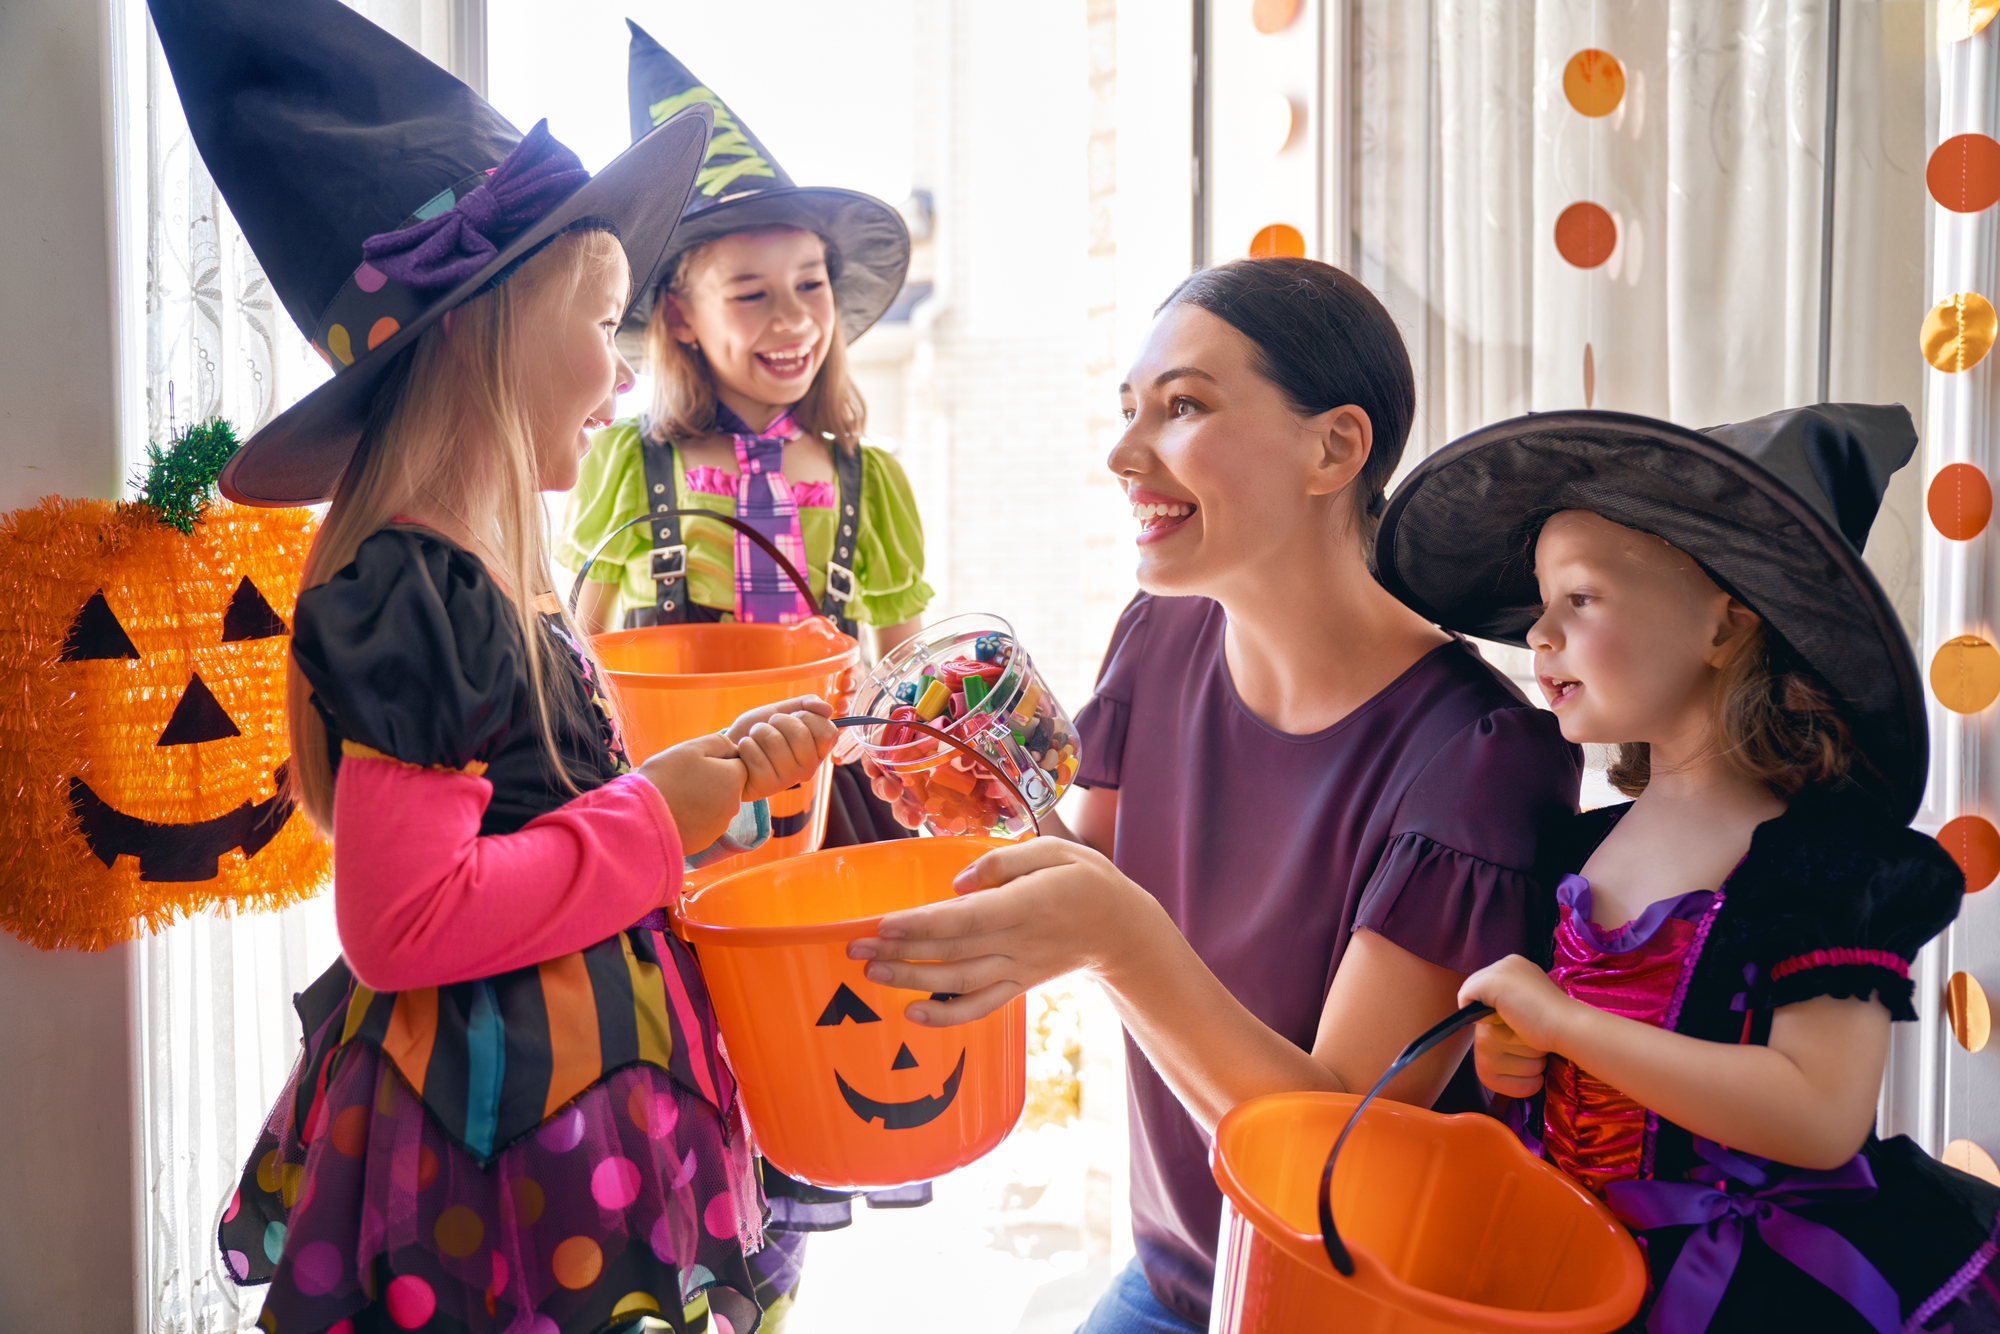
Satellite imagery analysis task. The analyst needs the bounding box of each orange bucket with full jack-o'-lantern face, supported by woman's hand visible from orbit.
[674,838,1028,1190]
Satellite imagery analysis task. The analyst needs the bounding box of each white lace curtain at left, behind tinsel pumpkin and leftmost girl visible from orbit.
[130,0,468,1334]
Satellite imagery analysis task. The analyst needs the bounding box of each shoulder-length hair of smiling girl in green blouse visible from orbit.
[646,224,868,454]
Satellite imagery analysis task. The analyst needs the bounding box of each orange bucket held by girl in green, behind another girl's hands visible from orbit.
[590,616,860,872]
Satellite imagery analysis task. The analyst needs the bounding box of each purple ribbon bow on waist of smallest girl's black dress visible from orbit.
[1604,1136,1902,1334]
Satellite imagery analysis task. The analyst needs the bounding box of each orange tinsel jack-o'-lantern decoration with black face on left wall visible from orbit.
[0,428,330,950]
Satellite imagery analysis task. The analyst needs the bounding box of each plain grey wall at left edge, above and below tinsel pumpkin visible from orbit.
[0,0,138,1330]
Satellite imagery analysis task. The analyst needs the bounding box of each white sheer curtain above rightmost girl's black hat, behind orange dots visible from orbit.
[1348,0,1932,632]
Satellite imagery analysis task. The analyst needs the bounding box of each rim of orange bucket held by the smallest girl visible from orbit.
[1210,1092,1646,1334]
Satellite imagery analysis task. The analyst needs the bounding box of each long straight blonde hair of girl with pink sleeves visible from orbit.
[286,230,622,836]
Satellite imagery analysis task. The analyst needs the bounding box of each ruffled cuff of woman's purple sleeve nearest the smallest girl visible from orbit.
[1354,834,1550,972]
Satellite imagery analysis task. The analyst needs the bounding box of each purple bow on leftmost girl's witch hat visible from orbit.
[362,120,590,292]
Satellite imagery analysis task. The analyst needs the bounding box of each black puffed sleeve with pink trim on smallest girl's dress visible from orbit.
[1730,796,1964,1020]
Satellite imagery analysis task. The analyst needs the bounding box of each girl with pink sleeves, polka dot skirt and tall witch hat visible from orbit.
[152,0,832,1334]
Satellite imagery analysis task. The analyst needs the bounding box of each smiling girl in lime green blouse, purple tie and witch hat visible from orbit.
[556,24,932,846]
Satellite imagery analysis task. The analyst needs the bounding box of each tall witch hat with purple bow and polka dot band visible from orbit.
[150,0,712,506]
